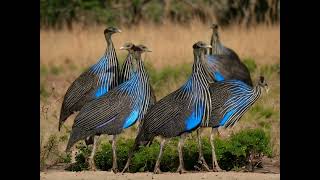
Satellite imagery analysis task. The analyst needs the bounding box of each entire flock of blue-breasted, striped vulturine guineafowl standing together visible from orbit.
[59,24,268,173]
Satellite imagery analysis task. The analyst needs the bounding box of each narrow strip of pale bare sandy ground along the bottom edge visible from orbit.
[40,171,280,180]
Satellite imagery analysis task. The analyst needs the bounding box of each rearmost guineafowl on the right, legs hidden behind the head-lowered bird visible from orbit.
[207,24,252,86]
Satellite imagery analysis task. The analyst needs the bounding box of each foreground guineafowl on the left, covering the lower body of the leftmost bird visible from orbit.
[66,45,151,173]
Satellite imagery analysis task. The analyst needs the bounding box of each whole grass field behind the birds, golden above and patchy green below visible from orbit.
[40,23,280,169]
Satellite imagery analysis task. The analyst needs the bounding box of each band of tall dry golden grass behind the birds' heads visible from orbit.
[40,22,280,68]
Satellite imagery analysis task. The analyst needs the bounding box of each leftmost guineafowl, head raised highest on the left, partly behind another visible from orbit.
[59,27,121,131]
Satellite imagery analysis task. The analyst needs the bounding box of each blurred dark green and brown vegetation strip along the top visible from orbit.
[40,0,280,29]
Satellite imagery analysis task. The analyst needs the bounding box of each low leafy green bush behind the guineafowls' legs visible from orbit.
[68,129,272,172]
